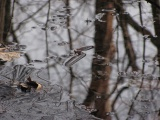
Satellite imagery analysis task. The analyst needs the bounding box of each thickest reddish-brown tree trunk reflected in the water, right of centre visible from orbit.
[84,0,115,120]
